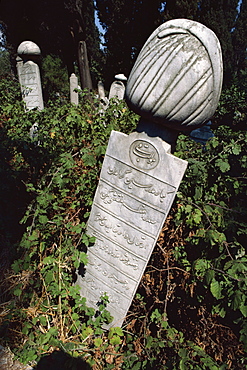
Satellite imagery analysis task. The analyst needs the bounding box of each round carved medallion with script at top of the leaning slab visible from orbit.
[130,140,159,170]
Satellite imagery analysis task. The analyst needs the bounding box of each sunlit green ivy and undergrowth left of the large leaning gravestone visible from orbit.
[1,83,136,363]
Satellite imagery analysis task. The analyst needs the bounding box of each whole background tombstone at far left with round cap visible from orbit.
[17,41,44,110]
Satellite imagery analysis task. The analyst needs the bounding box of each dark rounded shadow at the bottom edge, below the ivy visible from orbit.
[34,351,91,370]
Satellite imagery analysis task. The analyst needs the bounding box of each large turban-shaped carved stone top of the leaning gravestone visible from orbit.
[125,19,223,131]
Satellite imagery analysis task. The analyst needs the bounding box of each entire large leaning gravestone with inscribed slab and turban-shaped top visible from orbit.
[77,19,222,326]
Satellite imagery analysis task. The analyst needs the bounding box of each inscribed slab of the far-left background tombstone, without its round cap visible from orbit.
[17,58,44,110]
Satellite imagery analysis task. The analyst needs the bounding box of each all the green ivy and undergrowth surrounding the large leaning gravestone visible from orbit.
[0,77,247,370]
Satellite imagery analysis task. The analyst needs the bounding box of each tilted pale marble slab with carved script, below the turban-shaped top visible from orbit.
[77,131,187,326]
